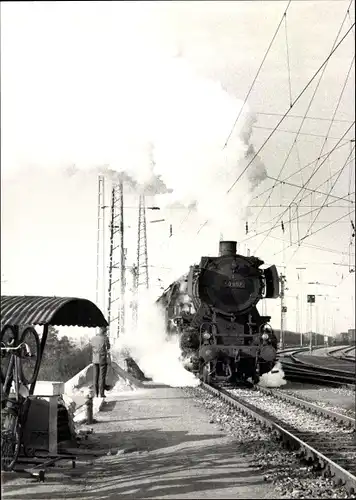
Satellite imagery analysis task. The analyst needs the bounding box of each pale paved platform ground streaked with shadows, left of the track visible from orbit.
[3,386,278,500]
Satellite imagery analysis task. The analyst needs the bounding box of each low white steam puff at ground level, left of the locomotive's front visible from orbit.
[113,293,199,387]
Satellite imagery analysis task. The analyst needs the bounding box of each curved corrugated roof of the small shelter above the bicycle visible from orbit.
[1,295,108,328]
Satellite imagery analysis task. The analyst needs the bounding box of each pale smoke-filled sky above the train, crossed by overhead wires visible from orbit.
[1,0,355,340]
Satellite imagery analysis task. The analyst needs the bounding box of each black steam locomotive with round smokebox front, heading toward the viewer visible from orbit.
[156,241,279,384]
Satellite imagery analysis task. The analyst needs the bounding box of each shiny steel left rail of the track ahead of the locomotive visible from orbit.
[201,382,356,494]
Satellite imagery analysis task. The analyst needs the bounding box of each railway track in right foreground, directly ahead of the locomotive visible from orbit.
[201,382,356,494]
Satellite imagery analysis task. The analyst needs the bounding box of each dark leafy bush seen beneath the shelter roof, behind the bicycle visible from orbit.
[38,326,91,382]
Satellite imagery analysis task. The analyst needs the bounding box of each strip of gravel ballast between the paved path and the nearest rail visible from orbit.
[184,388,356,498]
